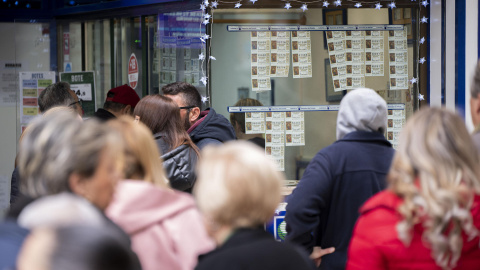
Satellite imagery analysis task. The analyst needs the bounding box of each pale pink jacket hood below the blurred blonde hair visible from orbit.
[105,180,196,235]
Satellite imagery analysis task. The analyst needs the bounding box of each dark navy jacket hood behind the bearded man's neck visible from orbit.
[188,108,236,145]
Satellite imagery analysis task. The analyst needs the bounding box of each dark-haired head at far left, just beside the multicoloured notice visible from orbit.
[38,82,83,116]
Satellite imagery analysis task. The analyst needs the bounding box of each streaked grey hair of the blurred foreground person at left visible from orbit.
[18,111,121,198]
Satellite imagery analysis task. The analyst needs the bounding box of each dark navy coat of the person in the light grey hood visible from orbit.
[285,131,395,270]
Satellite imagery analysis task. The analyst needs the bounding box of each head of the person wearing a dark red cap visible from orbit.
[93,84,140,121]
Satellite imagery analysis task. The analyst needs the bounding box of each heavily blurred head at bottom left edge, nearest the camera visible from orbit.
[17,226,138,270]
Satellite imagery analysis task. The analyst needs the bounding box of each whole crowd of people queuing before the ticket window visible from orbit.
[0,65,480,270]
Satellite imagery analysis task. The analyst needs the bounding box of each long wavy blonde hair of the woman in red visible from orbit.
[388,108,480,269]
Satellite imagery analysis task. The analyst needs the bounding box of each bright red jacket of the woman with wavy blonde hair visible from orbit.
[347,191,480,270]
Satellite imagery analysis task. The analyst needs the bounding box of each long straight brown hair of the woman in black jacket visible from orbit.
[133,95,199,155]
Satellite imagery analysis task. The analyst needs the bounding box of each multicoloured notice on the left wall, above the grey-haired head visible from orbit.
[19,72,55,124]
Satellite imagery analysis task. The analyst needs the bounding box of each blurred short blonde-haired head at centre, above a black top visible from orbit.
[194,141,284,229]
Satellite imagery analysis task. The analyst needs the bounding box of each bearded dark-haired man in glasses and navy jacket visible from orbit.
[162,82,236,149]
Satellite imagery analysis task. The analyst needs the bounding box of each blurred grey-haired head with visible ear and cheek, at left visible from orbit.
[18,110,123,210]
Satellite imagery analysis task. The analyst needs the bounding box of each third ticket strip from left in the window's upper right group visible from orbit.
[365,31,385,76]
